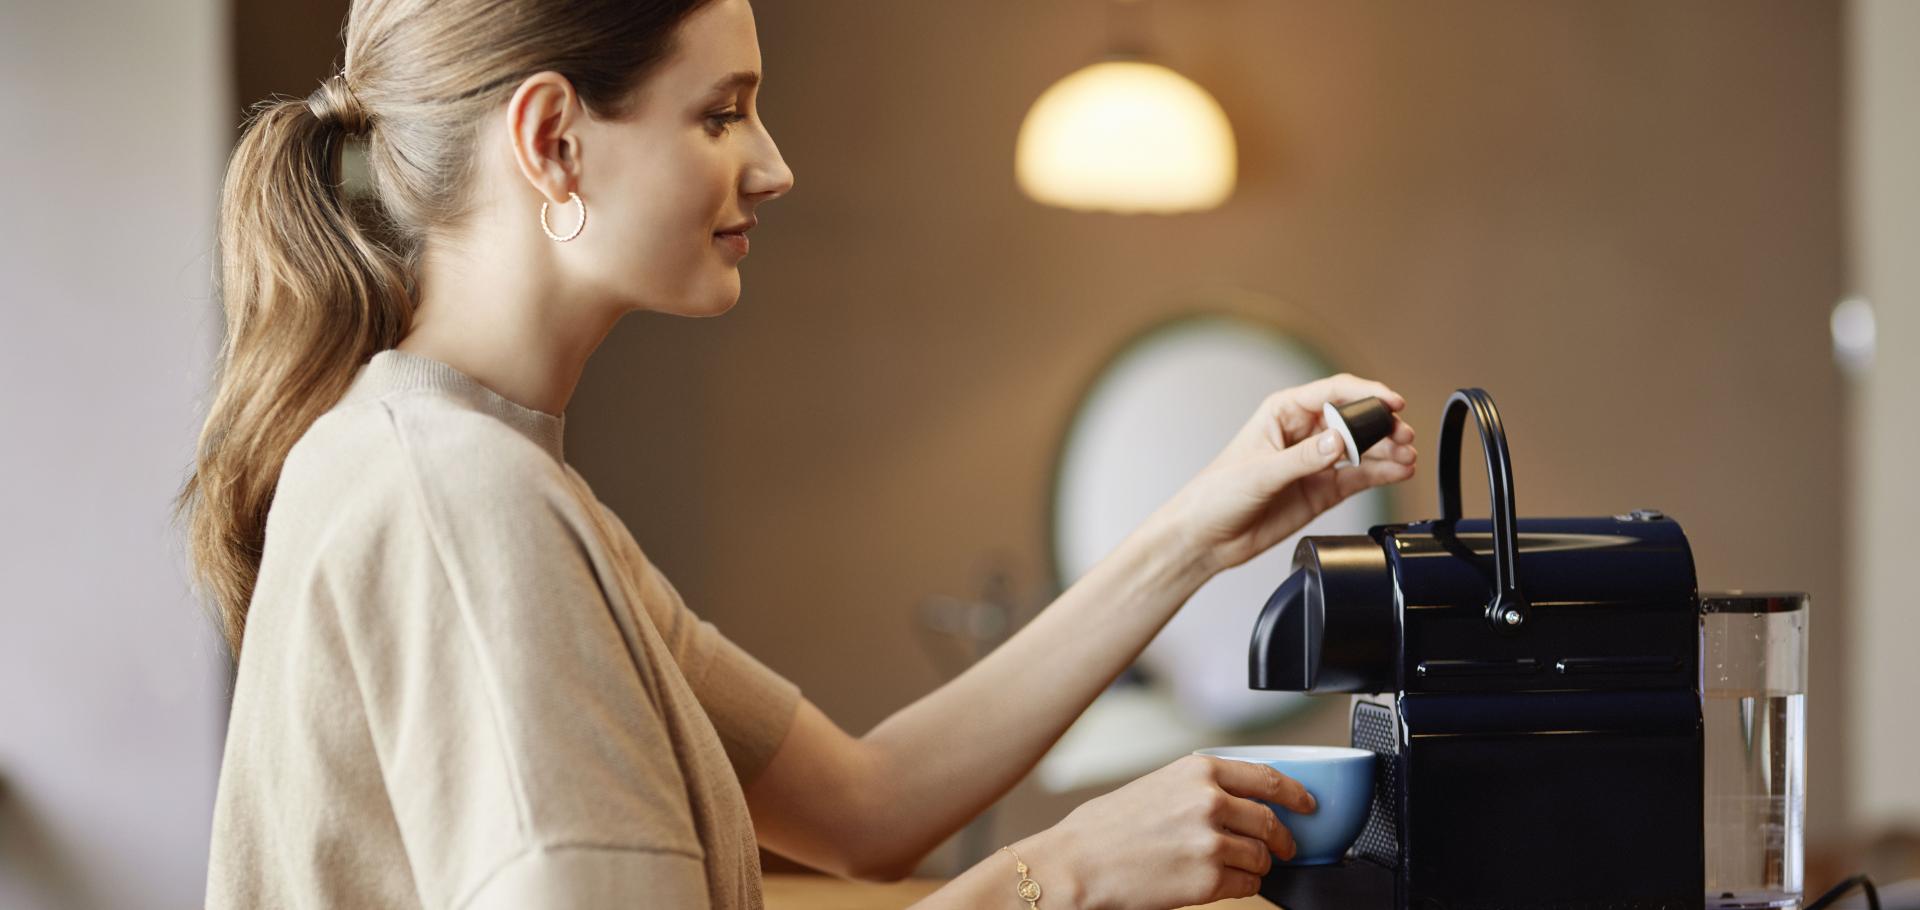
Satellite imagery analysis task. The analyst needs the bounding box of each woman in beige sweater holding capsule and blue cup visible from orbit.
[180,0,1415,910]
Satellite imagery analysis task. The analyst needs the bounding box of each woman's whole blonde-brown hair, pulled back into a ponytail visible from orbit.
[175,0,708,659]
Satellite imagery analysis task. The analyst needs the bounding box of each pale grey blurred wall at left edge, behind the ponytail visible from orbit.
[0,0,232,910]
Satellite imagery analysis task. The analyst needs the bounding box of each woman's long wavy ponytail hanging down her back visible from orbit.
[175,77,413,659]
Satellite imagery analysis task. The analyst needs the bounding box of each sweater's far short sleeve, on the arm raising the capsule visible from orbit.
[588,491,801,787]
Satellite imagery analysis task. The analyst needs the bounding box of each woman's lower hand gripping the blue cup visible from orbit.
[1006,754,1315,910]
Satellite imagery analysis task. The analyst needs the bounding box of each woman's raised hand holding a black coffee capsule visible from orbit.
[1152,372,1417,576]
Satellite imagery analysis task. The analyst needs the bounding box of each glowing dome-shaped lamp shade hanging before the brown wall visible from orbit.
[1014,60,1236,213]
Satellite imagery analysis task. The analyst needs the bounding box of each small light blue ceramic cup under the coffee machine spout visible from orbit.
[1194,745,1373,866]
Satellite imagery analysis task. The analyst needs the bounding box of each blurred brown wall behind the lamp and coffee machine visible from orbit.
[568,0,1847,870]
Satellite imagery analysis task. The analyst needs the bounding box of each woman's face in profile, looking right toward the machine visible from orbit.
[551,0,793,317]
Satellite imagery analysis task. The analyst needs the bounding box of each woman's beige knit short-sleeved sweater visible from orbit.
[207,349,799,910]
